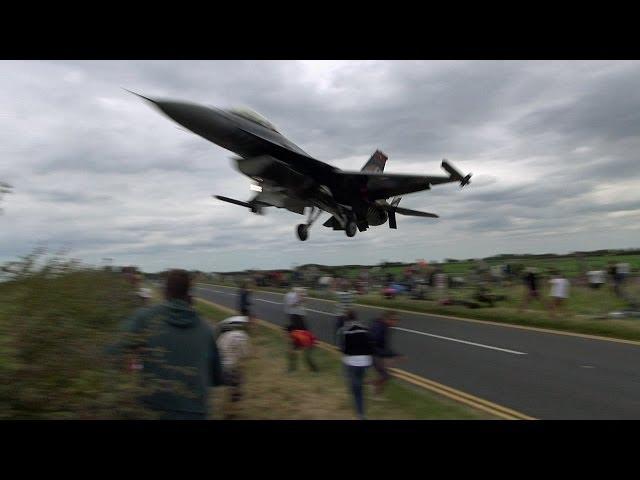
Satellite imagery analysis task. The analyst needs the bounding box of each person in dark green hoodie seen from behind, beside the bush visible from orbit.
[120,270,223,420]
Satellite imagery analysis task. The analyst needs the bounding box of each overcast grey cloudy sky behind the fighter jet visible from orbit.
[0,61,640,271]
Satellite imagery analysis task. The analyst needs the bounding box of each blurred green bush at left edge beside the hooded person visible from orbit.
[0,254,154,419]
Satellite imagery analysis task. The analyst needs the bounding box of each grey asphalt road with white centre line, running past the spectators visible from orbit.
[195,284,640,419]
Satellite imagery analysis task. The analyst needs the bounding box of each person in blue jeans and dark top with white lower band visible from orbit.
[337,311,373,420]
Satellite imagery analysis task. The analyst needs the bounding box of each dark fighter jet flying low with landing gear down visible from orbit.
[131,92,471,241]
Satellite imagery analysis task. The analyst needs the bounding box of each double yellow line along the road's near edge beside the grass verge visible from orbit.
[196,298,535,420]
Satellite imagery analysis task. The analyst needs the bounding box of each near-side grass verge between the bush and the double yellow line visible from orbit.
[197,302,492,419]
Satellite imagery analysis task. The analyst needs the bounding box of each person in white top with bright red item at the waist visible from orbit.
[284,287,318,372]
